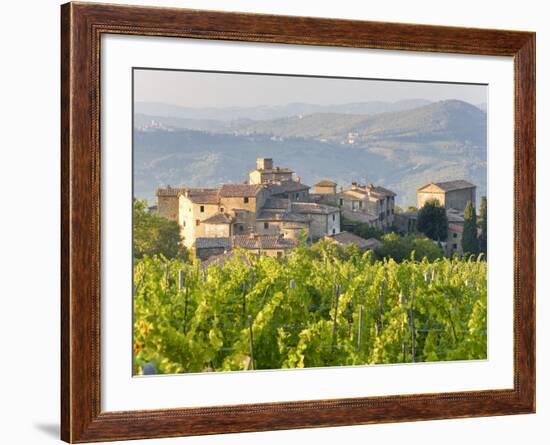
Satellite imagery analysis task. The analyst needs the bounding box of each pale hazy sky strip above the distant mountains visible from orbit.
[134,69,487,107]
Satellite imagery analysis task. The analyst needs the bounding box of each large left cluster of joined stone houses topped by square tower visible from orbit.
[157,158,340,258]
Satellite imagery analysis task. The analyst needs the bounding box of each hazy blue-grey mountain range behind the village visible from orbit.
[134,100,487,206]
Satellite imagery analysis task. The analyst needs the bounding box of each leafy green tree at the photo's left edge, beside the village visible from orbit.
[134,199,187,259]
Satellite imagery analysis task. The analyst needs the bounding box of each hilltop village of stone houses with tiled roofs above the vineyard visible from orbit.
[156,158,476,260]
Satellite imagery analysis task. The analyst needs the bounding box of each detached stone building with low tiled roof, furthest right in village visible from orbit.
[416,180,476,211]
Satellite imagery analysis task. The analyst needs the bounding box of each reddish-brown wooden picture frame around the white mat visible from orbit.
[61,3,535,443]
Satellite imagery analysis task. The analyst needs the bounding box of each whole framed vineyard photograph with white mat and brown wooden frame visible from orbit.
[61,3,535,443]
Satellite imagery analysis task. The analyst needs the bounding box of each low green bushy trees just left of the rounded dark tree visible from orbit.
[376,233,443,263]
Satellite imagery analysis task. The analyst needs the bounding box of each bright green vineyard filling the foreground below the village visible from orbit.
[134,241,487,374]
